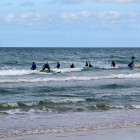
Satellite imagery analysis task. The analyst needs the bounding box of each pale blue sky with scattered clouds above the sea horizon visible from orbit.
[0,0,140,47]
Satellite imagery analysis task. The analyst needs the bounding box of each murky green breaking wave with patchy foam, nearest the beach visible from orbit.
[0,98,140,114]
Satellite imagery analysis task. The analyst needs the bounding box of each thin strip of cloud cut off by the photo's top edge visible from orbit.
[52,0,138,3]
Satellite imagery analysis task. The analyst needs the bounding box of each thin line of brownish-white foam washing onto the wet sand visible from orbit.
[0,124,139,138]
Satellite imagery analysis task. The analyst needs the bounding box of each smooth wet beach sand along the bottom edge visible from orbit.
[1,127,140,140]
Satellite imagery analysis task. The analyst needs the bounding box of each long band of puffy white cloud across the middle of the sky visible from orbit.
[0,10,140,29]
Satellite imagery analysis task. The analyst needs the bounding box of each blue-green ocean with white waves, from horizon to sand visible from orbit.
[0,48,140,138]
